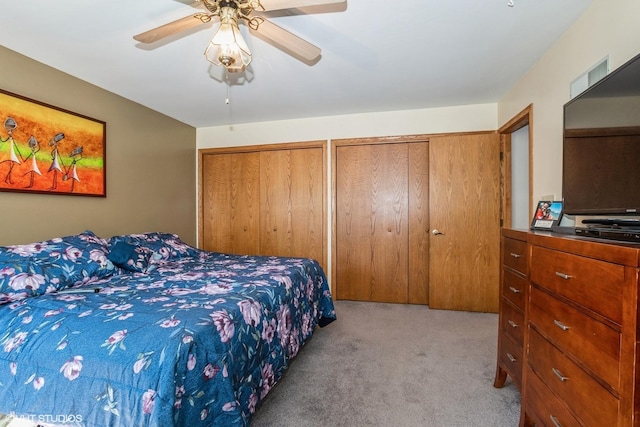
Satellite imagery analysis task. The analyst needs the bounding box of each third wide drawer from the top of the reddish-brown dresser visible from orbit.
[527,329,619,426]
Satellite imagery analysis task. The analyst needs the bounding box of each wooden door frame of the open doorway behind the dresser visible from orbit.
[498,104,533,228]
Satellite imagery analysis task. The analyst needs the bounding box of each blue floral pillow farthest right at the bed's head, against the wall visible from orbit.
[109,232,200,264]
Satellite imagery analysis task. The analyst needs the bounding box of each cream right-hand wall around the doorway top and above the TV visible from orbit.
[498,0,640,204]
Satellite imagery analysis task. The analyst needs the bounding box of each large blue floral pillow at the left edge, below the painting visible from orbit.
[0,231,115,303]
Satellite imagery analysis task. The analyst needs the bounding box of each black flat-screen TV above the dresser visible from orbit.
[562,51,640,216]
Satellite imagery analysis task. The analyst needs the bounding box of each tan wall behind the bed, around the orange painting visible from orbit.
[0,46,196,246]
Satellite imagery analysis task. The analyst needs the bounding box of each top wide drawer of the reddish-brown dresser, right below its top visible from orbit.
[531,246,624,324]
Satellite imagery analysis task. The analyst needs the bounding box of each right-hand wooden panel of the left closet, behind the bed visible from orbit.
[260,148,326,268]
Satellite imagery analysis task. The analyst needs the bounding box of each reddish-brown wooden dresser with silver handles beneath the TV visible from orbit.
[496,230,640,427]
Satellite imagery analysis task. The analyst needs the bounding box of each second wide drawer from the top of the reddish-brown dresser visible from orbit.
[529,286,620,390]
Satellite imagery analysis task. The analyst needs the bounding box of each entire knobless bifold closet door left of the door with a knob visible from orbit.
[334,142,428,304]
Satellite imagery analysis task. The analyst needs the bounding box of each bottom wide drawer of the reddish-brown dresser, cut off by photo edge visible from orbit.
[526,370,580,427]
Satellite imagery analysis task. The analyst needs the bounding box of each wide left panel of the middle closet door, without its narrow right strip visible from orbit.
[334,144,408,303]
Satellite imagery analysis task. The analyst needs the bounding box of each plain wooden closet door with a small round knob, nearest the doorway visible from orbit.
[429,133,500,312]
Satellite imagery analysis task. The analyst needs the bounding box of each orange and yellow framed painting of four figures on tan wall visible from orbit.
[0,89,107,197]
